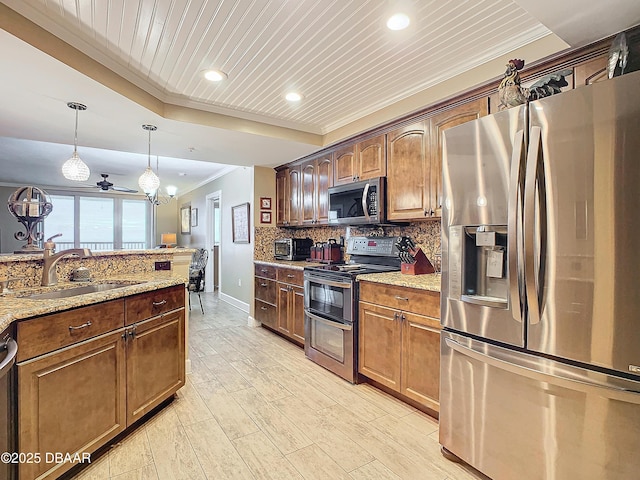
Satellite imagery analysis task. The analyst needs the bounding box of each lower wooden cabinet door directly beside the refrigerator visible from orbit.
[400,312,440,412]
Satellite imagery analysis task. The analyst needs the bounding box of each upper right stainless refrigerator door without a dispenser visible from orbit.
[524,72,640,375]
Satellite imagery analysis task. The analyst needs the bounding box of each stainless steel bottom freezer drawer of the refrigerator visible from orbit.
[439,331,640,480]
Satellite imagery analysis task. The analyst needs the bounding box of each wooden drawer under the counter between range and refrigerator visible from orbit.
[360,281,440,319]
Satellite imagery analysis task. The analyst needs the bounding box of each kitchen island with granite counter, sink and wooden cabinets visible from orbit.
[0,249,193,479]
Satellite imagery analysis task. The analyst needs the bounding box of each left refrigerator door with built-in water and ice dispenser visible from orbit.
[441,106,526,346]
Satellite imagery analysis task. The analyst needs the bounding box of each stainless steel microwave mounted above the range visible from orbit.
[329,177,386,225]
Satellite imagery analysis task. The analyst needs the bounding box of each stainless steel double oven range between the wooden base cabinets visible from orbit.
[304,237,400,383]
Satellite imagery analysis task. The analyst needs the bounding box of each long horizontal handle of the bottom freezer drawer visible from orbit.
[444,338,640,405]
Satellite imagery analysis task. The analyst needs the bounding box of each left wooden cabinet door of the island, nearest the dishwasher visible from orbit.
[18,329,126,479]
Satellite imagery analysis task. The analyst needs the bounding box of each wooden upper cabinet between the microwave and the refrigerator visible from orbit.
[387,98,488,221]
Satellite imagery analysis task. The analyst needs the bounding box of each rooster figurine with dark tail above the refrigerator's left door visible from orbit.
[498,59,573,110]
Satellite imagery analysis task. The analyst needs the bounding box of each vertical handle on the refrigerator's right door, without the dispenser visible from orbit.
[523,126,546,325]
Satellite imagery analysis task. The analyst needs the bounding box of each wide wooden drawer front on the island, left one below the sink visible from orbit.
[17,299,124,362]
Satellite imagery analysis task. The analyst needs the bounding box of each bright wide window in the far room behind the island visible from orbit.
[44,194,151,251]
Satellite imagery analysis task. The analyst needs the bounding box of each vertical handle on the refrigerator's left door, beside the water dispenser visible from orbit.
[507,130,525,323]
